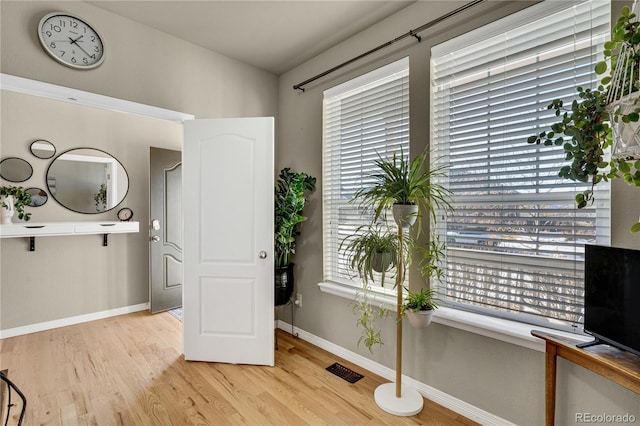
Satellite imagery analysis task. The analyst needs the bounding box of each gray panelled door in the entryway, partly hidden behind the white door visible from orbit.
[149,147,182,313]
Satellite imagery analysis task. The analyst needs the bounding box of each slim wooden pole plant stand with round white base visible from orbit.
[373,226,424,416]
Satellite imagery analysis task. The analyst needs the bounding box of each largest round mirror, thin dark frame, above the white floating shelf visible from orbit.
[47,148,129,214]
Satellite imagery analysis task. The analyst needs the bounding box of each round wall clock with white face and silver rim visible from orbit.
[38,13,104,70]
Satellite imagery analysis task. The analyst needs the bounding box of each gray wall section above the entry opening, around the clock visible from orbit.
[0,0,278,118]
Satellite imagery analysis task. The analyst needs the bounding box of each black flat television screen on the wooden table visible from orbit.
[584,245,640,355]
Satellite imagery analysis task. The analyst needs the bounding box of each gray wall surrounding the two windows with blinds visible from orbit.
[276,1,640,425]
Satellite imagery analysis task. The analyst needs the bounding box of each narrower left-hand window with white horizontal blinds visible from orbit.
[322,58,409,286]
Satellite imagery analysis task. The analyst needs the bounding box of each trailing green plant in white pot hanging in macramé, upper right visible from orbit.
[527,6,640,232]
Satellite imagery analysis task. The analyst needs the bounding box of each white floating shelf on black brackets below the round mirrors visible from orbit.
[0,220,140,251]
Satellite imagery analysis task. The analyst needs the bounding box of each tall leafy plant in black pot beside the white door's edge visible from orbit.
[274,167,316,306]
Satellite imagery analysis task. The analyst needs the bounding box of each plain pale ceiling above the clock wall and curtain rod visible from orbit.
[89,0,415,75]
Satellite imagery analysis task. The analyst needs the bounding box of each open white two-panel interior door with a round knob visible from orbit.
[182,118,274,365]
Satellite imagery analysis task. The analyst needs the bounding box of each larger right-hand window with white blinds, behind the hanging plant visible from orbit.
[431,1,610,328]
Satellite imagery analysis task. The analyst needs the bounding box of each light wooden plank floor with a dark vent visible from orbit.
[0,312,474,425]
